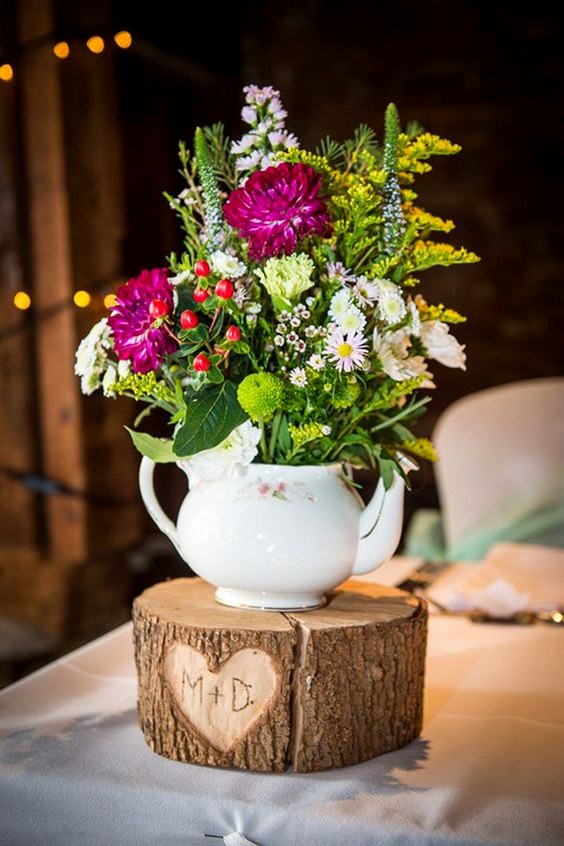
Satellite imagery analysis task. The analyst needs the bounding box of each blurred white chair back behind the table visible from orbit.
[433,378,564,549]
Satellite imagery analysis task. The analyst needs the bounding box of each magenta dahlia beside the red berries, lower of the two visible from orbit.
[108,268,177,373]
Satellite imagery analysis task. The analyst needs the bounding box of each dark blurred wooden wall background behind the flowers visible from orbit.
[0,0,564,681]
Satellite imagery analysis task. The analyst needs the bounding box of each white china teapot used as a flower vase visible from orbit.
[139,456,417,611]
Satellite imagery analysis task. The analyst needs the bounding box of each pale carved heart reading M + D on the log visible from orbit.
[164,643,278,752]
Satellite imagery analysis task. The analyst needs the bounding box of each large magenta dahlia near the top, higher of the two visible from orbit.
[223,162,329,259]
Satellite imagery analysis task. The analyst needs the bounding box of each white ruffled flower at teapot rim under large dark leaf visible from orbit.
[176,420,261,485]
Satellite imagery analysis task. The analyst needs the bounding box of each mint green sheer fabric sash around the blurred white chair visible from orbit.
[404,481,564,561]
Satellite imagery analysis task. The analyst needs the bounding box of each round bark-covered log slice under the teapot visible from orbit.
[133,579,427,772]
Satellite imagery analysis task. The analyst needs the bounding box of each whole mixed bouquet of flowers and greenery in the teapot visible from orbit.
[75,85,478,486]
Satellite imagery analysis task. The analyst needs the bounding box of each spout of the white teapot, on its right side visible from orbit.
[352,455,418,576]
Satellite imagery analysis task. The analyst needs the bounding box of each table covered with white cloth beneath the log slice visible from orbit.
[0,584,564,846]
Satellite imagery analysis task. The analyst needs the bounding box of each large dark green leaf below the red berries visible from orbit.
[174,382,247,457]
